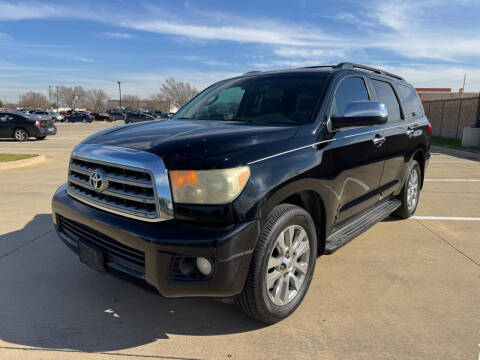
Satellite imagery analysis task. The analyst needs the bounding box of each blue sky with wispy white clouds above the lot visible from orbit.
[0,0,480,102]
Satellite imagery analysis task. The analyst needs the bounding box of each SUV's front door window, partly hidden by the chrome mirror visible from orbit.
[331,77,369,116]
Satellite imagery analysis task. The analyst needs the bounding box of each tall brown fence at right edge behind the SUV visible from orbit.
[422,96,480,139]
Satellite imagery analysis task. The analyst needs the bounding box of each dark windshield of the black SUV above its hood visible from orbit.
[174,73,329,125]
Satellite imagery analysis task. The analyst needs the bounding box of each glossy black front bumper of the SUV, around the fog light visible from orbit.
[52,184,259,297]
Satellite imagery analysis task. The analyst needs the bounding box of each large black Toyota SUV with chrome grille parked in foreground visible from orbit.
[53,63,431,323]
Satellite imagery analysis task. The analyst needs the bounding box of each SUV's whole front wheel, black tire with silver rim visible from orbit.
[234,204,317,324]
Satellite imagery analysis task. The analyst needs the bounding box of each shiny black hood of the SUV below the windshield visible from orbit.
[84,119,297,169]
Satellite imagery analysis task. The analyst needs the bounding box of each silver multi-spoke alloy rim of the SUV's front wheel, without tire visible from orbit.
[266,225,310,306]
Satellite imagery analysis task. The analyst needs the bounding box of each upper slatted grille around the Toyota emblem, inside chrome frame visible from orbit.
[68,157,159,221]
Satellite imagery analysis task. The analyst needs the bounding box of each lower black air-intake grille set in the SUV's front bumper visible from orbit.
[59,216,145,277]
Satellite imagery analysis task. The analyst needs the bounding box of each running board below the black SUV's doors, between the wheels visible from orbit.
[325,199,401,255]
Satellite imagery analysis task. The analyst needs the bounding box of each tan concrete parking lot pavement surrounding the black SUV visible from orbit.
[0,123,480,359]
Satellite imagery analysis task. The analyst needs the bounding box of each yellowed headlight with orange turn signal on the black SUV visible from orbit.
[170,166,250,205]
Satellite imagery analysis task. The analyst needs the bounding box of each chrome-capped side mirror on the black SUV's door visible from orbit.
[330,100,388,130]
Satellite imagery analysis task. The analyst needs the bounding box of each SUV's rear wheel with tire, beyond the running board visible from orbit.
[393,160,422,219]
